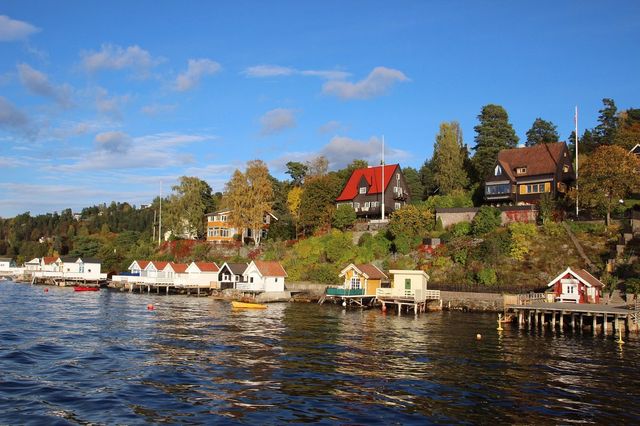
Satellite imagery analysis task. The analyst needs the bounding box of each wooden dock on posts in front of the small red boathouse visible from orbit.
[505,302,639,335]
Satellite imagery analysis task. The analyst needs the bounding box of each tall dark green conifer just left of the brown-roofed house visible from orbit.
[473,104,519,179]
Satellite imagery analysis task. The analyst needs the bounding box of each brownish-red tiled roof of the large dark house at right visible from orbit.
[492,142,566,179]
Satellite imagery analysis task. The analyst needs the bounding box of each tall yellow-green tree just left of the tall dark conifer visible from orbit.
[432,121,469,195]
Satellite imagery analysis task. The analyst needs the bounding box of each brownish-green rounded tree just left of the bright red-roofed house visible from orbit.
[300,173,342,233]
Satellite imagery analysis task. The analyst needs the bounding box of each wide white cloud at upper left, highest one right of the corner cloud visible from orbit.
[80,44,163,77]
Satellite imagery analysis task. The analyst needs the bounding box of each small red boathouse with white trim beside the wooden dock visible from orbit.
[547,268,604,303]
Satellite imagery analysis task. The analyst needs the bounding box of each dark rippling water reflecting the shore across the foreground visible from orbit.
[0,282,640,424]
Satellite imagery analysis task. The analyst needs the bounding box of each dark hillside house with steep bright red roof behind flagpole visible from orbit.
[336,164,411,218]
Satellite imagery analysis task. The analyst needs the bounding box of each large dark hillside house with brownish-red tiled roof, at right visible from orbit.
[484,142,576,204]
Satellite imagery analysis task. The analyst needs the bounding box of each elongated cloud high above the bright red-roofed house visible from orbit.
[322,67,409,100]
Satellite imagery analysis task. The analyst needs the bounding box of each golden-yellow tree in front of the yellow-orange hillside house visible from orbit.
[225,160,273,246]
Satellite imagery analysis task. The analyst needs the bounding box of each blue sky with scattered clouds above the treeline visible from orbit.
[0,0,640,217]
